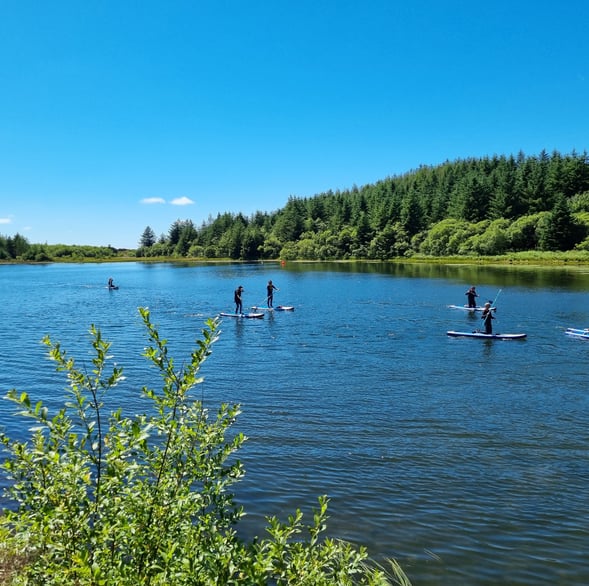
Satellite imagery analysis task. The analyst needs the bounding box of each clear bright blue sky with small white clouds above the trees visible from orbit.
[0,0,589,248]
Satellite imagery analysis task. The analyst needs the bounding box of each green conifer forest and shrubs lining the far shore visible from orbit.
[0,151,589,260]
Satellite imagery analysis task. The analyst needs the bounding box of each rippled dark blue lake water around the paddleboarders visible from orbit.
[0,263,589,586]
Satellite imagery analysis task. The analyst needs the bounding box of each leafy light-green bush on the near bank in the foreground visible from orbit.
[0,309,409,586]
